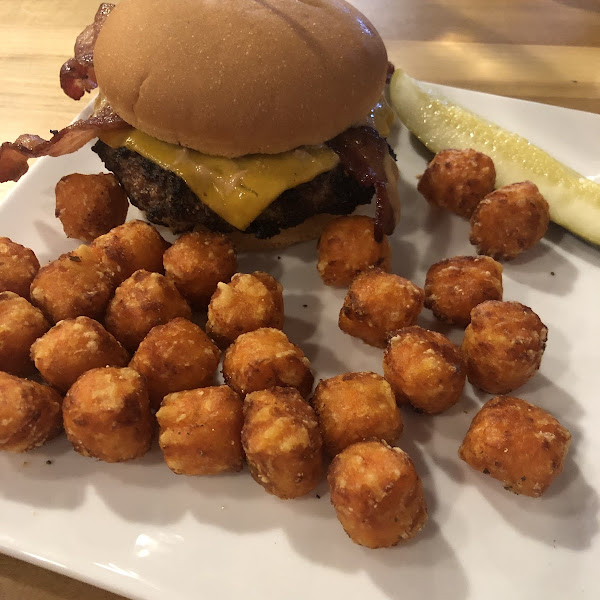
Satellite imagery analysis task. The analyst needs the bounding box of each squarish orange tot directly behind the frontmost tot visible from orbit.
[311,373,403,456]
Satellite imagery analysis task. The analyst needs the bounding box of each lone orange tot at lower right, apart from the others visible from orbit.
[458,396,571,498]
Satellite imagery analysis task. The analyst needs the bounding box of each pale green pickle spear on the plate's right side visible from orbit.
[390,70,600,244]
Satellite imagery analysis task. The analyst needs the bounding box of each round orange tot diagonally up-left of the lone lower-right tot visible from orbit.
[383,325,466,415]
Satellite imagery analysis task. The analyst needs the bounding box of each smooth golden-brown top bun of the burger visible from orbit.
[94,0,387,157]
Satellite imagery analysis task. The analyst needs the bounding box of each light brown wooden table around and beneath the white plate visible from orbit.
[0,0,600,600]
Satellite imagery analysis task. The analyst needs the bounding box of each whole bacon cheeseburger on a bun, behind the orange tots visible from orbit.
[0,0,404,247]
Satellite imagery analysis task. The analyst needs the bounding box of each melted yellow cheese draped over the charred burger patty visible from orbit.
[100,96,394,231]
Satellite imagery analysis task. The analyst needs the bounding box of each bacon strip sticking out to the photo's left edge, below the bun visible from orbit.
[0,105,130,183]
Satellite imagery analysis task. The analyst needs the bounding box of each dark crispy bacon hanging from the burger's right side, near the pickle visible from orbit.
[327,126,396,242]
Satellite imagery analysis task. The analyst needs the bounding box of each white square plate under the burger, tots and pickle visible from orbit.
[0,83,600,600]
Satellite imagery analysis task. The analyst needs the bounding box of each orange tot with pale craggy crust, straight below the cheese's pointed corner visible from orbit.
[206,271,284,348]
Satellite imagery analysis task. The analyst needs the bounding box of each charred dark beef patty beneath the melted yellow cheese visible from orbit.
[92,141,374,239]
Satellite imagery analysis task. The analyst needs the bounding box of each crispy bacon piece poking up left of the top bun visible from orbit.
[60,2,115,100]
